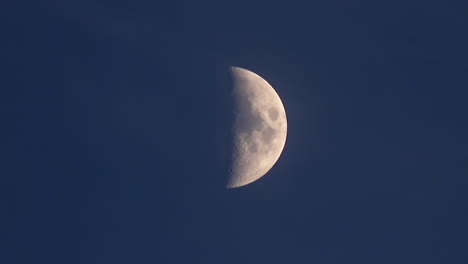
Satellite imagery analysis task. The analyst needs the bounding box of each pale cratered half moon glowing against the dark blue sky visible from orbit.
[226,67,287,188]
